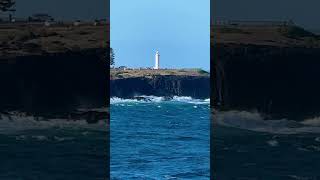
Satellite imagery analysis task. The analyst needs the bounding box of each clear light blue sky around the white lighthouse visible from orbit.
[110,0,210,70]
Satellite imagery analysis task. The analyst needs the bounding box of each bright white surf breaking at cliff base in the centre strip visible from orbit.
[110,96,210,104]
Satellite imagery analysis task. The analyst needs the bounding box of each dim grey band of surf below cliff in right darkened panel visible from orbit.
[212,111,320,134]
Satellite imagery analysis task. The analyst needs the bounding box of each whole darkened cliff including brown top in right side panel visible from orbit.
[211,23,320,121]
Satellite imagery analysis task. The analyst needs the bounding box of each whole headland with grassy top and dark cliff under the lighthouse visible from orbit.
[110,69,210,99]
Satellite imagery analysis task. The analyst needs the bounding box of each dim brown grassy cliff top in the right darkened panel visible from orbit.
[211,25,320,48]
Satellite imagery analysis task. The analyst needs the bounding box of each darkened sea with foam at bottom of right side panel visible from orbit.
[212,111,320,180]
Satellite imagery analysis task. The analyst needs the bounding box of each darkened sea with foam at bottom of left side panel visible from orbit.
[0,115,109,180]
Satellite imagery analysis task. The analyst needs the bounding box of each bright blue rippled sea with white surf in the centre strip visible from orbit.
[110,97,210,180]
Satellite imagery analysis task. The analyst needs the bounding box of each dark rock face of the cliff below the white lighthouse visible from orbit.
[110,75,210,99]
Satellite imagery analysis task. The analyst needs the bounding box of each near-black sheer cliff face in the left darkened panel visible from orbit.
[0,49,109,114]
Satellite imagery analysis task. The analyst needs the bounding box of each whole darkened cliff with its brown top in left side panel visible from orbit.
[0,22,109,122]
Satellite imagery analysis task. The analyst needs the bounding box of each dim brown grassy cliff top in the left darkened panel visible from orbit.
[0,22,109,58]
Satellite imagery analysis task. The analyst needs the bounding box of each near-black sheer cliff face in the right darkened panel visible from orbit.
[211,44,320,120]
